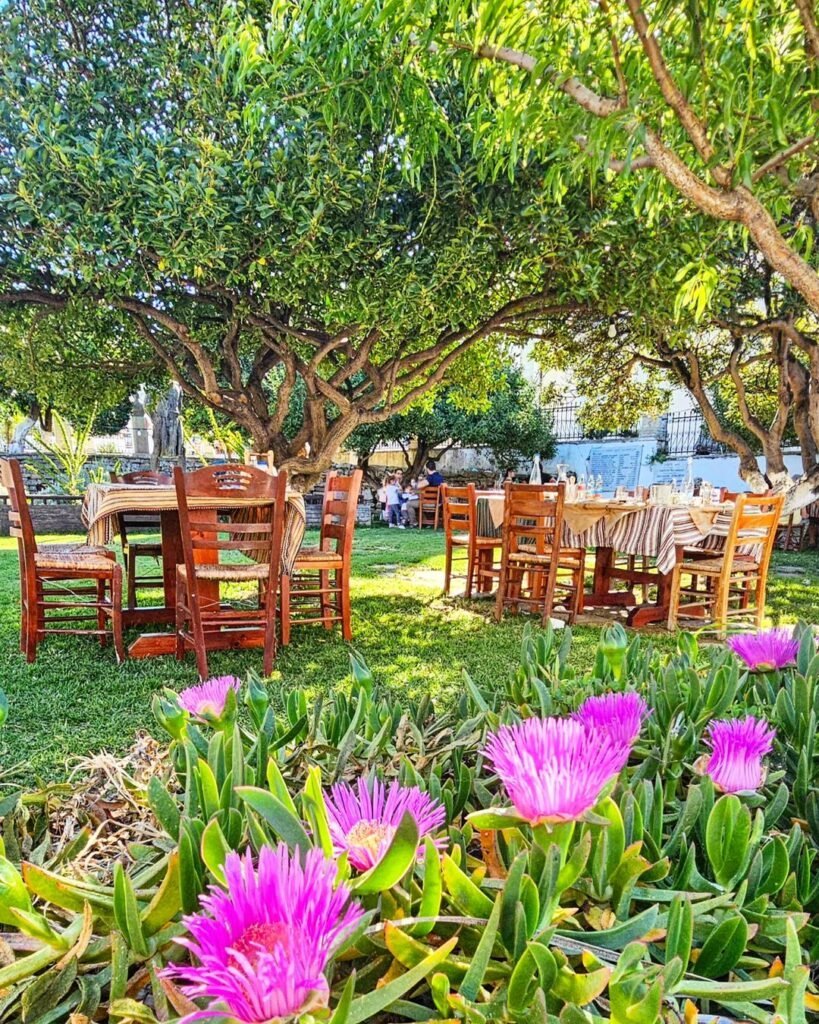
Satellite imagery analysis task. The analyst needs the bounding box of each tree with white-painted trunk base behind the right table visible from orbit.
[524,224,819,509]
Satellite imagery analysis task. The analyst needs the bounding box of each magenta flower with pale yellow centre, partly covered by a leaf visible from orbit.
[326,778,446,871]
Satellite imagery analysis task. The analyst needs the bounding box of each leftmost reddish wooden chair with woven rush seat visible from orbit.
[0,459,125,662]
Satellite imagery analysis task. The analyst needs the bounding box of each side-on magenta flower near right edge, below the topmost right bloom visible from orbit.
[704,715,776,793]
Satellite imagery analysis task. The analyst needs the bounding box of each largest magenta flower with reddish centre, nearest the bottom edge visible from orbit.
[167,844,363,1024]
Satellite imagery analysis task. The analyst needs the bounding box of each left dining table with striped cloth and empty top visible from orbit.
[81,483,307,657]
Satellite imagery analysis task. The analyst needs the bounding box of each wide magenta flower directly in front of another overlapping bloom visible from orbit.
[485,718,630,824]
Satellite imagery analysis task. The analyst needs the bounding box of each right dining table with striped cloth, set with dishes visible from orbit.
[477,490,733,627]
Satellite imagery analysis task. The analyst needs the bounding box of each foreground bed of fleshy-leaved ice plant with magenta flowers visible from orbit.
[0,626,819,1024]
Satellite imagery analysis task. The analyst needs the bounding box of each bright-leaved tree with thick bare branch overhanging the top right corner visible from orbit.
[401,0,819,313]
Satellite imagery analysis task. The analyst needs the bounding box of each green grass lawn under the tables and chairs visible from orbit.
[0,528,819,781]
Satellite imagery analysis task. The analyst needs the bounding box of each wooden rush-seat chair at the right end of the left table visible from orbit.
[281,469,363,644]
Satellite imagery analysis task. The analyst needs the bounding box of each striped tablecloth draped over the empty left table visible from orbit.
[81,483,307,573]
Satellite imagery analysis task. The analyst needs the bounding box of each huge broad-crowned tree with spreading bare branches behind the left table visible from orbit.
[0,0,598,483]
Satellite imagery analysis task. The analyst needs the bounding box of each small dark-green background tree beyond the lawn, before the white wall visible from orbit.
[348,369,555,477]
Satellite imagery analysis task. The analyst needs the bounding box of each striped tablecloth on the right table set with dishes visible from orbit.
[477,495,732,572]
